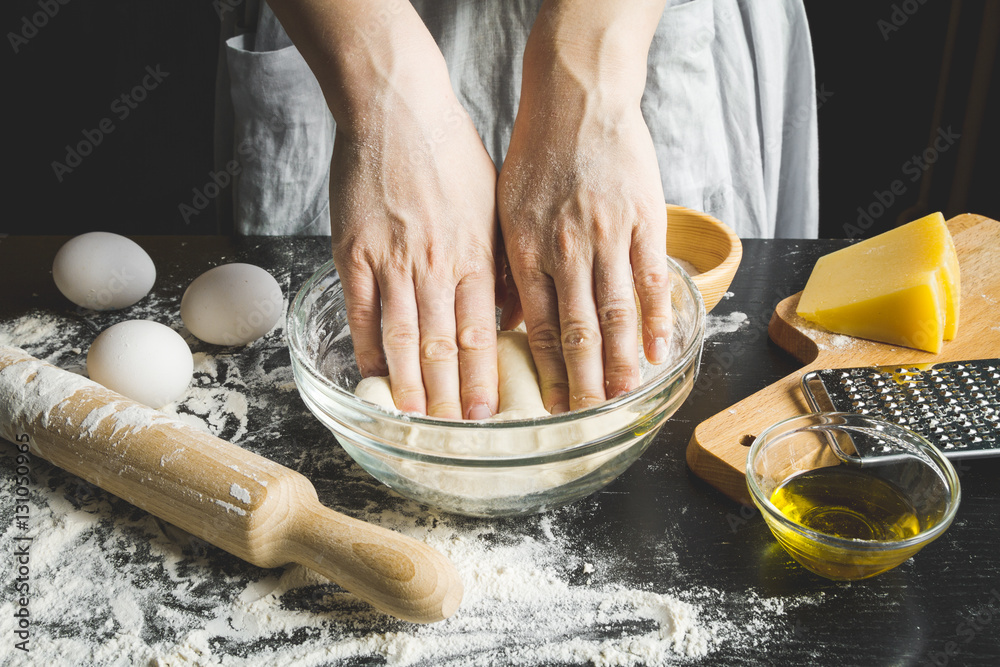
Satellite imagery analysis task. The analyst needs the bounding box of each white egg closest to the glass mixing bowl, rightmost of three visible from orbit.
[181,264,284,345]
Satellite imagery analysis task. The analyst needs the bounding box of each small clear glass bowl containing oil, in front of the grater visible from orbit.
[746,412,961,580]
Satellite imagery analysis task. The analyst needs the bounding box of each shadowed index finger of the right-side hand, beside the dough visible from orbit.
[518,272,569,414]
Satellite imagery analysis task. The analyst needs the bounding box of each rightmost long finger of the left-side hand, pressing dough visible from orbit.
[455,272,499,419]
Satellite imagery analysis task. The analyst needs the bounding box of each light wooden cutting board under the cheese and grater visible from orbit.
[687,213,1000,504]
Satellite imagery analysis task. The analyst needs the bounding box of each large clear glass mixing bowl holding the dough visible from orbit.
[287,258,705,517]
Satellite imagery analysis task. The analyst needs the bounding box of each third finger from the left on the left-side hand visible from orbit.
[416,278,462,419]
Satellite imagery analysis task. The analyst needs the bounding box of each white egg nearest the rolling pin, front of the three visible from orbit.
[87,320,194,408]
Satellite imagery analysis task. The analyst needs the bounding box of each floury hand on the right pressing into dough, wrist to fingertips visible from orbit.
[498,2,671,412]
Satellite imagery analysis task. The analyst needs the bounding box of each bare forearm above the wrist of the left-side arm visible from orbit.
[268,0,450,131]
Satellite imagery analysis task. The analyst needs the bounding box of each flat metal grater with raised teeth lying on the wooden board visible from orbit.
[802,359,1000,458]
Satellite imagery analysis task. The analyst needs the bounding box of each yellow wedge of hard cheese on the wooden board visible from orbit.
[796,213,961,353]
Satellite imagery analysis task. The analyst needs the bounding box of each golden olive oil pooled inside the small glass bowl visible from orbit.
[771,465,921,542]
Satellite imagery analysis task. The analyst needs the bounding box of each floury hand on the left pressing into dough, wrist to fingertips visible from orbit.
[330,51,501,419]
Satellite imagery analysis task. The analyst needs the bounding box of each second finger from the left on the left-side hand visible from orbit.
[379,274,427,414]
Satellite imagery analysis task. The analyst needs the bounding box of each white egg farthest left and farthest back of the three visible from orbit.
[52,232,156,310]
